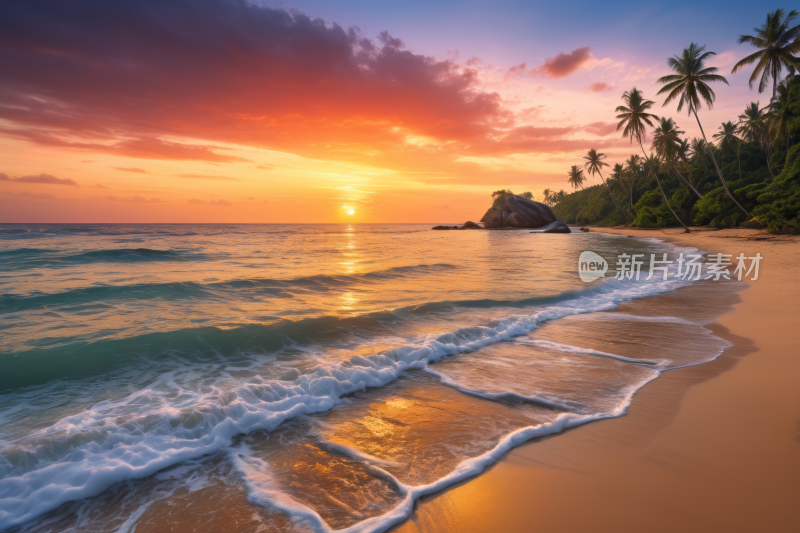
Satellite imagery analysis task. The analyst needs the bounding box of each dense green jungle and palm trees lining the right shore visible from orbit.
[544,9,800,233]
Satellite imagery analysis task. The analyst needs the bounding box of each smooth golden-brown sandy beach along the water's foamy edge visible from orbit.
[392,227,800,533]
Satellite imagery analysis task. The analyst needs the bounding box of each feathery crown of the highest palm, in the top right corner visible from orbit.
[731,8,800,98]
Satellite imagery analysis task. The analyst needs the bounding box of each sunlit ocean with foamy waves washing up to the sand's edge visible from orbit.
[0,224,741,533]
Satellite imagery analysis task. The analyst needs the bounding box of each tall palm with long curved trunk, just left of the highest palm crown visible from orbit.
[658,43,750,218]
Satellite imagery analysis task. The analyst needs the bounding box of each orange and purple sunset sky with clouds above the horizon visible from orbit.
[0,0,782,223]
